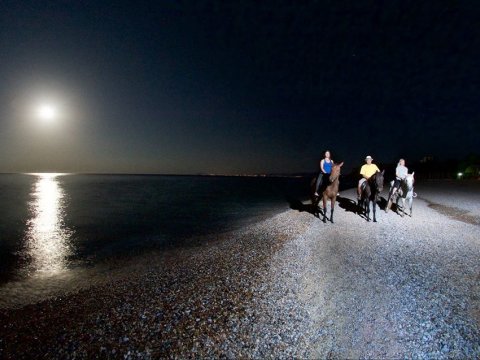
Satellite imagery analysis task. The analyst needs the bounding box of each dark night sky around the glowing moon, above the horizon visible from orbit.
[0,0,480,174]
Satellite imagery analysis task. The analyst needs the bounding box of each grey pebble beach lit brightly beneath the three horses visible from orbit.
[0,183,480,359]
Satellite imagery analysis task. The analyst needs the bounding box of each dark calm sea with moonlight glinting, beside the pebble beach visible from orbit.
[0,173,311,307]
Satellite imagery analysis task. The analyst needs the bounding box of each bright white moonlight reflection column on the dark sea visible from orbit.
[25,173,72,276]
